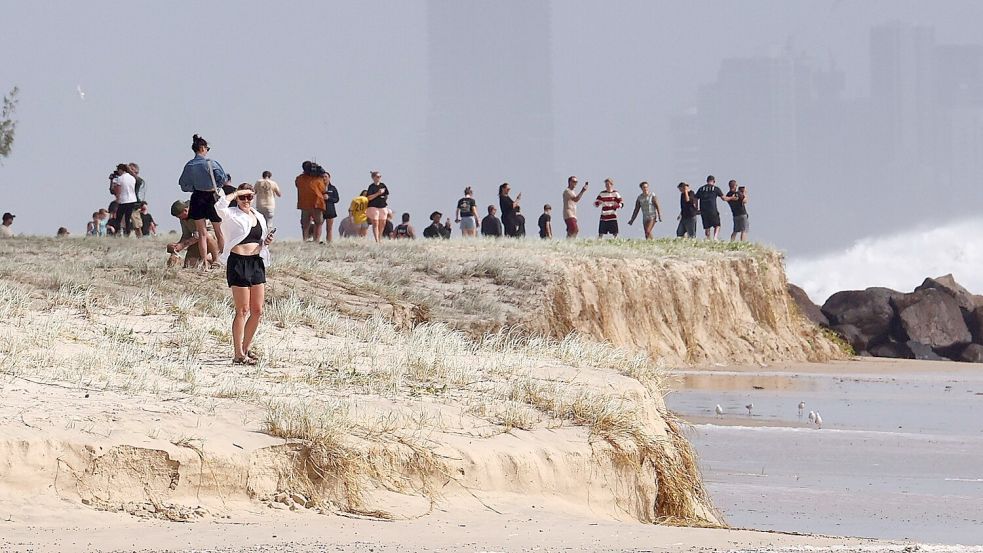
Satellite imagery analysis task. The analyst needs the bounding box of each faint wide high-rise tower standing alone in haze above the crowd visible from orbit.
[425,0,556,194]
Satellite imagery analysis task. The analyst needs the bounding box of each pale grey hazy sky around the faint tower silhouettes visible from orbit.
[0,0,983,264]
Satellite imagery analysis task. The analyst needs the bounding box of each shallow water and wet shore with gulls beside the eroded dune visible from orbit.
[666,364,983,545]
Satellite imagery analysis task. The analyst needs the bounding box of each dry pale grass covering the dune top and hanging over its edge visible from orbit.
[0,238,732,526]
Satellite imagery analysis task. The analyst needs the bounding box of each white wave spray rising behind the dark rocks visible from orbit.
[787,219,983,305]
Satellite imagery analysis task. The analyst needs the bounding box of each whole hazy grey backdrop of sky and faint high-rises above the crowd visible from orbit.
[0,0,983,256]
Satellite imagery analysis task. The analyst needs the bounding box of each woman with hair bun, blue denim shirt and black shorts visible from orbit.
[178,134,229,269]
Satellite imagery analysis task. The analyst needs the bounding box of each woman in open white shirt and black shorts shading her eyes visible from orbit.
[214,183,276,365]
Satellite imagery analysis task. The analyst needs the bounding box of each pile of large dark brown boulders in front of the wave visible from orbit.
[793,275,983,363]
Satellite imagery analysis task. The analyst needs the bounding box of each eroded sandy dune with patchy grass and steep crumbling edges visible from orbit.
[0,239,856,548]
